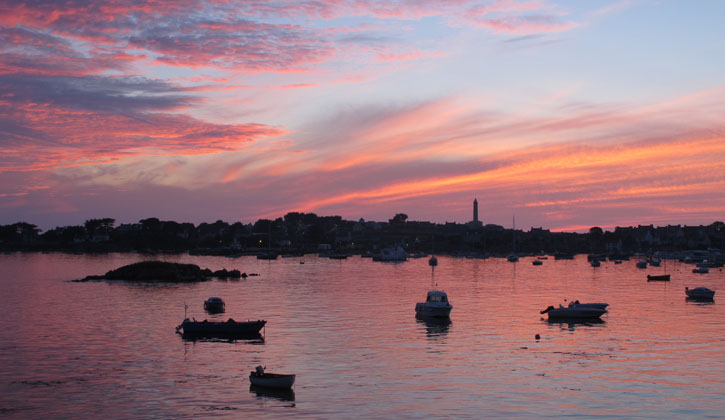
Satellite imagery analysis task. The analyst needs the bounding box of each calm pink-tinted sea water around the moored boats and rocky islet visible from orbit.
[0,253,725,419]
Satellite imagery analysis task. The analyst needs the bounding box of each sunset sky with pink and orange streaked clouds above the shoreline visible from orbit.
[0,0,725,231]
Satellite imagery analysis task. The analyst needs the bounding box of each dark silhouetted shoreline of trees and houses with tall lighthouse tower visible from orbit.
[0,200,725,258]
